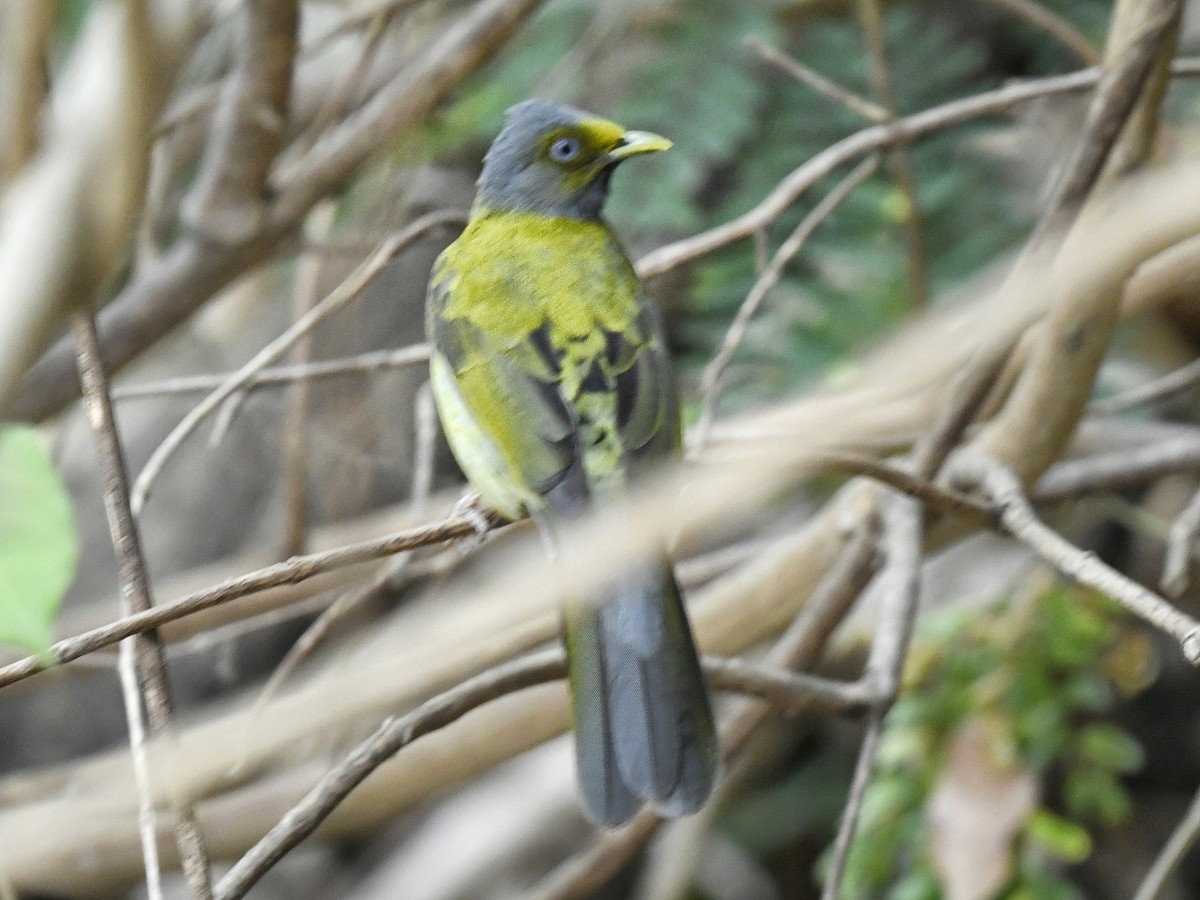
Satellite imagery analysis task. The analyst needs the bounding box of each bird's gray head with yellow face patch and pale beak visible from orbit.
[475,100,671,220]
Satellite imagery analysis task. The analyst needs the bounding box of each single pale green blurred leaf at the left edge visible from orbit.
[0,425,77,652]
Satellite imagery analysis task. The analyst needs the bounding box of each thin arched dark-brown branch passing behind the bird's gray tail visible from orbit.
[216,647,865,900]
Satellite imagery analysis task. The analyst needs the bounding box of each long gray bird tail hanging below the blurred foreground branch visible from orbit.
[566,559,721,828]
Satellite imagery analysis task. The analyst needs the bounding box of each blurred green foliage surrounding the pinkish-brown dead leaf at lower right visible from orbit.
[825,588,1142,900]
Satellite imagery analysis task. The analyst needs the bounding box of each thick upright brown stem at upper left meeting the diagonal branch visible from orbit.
[180,0,300,246]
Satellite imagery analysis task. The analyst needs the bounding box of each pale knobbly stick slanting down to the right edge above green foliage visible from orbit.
[948,458,1200,665]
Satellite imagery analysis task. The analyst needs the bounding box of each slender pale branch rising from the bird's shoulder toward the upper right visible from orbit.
[637,60,1200,277]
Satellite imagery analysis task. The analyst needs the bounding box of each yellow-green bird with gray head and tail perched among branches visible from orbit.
[426,100,721,828]
